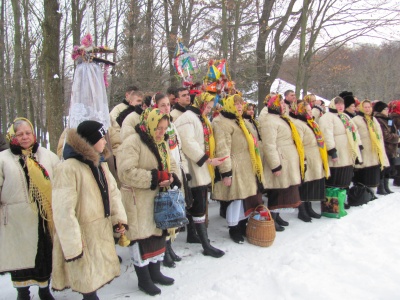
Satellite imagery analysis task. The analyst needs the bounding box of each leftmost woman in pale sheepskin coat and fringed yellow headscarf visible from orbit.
[0,118,59,300]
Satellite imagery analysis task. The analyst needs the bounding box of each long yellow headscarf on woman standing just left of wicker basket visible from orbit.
[223,95,264,182]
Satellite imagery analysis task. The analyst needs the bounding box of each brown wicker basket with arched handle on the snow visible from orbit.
[246,205,276,247]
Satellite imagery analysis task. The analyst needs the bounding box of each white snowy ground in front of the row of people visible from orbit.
[0,188,400,300]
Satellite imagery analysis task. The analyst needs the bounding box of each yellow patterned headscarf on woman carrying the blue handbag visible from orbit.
[139,108,171,172]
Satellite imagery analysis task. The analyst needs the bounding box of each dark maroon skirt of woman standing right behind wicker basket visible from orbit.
[267,185,301,210]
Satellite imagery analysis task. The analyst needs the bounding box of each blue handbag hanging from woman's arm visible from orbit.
[154,189,189,229]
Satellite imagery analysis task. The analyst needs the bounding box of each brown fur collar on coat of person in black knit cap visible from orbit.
[63,129,109,167]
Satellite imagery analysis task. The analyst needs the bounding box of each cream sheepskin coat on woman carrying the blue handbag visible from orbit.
[117,125,180,241]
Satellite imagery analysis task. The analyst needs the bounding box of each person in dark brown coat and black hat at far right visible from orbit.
[374,101,399,195]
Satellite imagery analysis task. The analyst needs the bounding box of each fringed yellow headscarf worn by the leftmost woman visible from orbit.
[7,118,54,236]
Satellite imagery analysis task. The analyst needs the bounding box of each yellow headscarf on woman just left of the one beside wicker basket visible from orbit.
[193,92,215,187]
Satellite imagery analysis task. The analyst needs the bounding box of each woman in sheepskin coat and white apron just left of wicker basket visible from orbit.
[211,95,265,244]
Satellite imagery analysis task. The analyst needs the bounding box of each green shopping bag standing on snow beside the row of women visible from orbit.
[321,188,347,219]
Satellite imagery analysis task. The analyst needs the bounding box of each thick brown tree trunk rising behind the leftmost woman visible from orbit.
[42,0,64,152]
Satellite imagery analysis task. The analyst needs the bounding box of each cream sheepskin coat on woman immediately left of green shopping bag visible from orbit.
[293,119,325,182]
